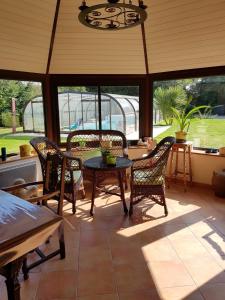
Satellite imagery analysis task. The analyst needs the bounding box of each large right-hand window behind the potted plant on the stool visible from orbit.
[153,75,225,148]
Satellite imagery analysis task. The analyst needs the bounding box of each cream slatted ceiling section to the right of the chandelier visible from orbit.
[145,0,225,73]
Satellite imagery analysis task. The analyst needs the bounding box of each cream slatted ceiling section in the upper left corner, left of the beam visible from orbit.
[0,0,56,73]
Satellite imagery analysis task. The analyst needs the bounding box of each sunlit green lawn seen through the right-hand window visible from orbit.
[155,119,225,148]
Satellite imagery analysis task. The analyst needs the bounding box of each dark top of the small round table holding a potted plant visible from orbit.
[84,156,132,171]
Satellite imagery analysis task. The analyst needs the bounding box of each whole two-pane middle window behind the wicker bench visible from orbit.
[58,86,139,142]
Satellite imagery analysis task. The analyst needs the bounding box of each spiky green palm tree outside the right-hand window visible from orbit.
[154,86,186,125]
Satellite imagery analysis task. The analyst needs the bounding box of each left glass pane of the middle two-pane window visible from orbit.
[58,86,99,142]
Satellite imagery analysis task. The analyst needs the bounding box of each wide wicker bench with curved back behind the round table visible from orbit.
[67,130,128,188]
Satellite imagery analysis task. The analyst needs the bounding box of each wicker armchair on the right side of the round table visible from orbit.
[129,137,175,215]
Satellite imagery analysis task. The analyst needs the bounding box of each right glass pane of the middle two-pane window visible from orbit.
[101,86,139,140]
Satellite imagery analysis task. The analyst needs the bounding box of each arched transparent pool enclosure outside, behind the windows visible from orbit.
[23,91,139,137]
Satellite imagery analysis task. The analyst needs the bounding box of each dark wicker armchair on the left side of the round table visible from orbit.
[30,137,85,215]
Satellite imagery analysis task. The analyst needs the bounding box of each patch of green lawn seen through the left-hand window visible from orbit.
[0,127,31,153]
